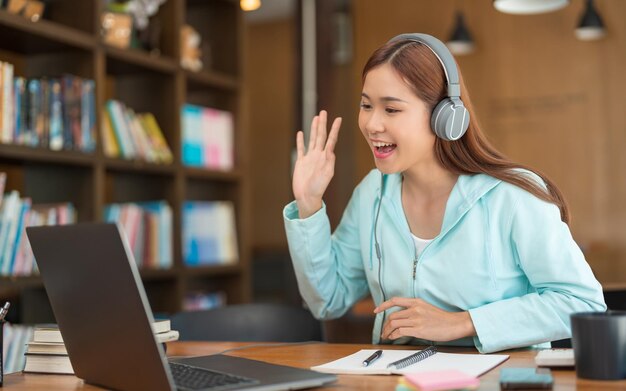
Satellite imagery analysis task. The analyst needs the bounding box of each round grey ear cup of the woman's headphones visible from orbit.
[430,98,470,141]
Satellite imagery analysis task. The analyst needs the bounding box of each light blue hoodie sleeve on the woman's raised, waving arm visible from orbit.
[283,190,369,319]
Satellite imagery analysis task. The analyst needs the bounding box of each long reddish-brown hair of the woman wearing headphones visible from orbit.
[362,41,570,224]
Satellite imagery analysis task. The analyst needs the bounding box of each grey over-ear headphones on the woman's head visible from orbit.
[389,33,470,141]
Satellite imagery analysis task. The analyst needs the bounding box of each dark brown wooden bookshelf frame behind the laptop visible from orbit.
[0,0,250,323]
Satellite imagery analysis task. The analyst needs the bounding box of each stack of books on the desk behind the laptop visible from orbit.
[24,319,179,375]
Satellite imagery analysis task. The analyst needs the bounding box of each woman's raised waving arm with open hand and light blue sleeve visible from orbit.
[283,111,368,319]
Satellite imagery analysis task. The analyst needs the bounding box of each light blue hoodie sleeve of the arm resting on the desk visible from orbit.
[469,192,606,353]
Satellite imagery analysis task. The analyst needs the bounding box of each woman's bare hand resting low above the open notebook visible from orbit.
[374,297,476,342]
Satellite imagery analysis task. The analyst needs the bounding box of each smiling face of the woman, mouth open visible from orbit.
[359,64,436,174]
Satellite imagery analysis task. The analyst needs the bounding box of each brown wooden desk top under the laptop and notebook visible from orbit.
[4,342,626,391]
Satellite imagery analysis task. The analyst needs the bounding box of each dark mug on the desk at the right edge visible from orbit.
[570,311,626,380]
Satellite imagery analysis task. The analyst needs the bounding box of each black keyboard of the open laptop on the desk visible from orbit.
[169,362,259,391]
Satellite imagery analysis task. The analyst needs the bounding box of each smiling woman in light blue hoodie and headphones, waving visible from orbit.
[284,34,606,353]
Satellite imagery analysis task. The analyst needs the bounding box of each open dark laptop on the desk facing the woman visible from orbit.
[26,223,336,391]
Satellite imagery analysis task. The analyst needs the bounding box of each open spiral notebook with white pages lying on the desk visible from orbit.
[311,349,509,376]
